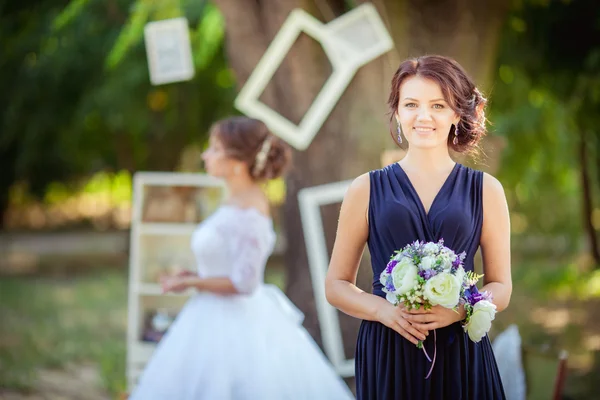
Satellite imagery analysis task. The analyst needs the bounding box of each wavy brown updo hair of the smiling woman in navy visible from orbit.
[388,55,487,154]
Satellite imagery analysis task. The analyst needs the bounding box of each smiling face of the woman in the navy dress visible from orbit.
[397,76,459,149]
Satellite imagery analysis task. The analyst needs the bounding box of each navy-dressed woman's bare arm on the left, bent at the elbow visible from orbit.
[325,174,425,344]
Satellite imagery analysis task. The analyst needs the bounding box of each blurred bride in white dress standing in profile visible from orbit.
[130,117,353,400]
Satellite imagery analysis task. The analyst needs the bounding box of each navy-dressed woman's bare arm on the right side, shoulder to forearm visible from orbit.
[480,174,512,311]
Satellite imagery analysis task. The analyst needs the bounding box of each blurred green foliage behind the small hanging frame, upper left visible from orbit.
[0,0,234,213]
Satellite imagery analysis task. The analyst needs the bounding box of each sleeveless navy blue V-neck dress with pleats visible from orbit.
[356,164,505,400]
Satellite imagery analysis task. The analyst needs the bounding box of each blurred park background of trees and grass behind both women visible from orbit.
[0,0,600,399]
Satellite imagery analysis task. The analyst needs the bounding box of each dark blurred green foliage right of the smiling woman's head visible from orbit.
[490,0,600,241]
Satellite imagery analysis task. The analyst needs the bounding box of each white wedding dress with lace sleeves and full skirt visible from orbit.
[130,205,354,400]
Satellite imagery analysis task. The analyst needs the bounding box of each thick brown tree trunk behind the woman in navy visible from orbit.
[216,0,507,358]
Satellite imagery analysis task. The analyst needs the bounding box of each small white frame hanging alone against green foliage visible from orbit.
[144,17,194,86]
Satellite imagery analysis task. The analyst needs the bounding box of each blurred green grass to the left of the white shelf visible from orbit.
[0,270,127,393]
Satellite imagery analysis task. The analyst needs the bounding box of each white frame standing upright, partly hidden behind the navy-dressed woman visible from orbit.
[298,180,355,377]
